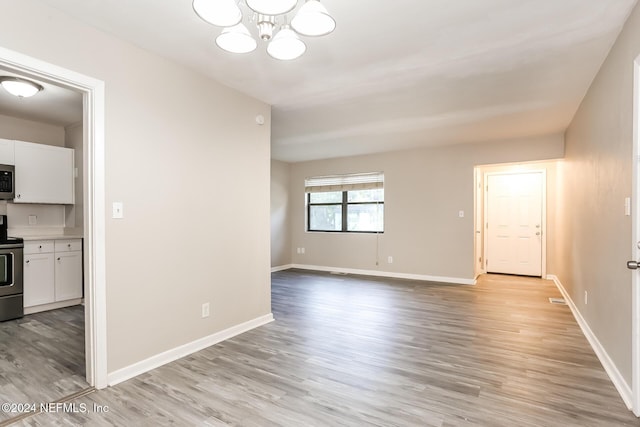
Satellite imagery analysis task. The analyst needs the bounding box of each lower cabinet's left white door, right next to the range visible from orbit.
[23,253,55,307]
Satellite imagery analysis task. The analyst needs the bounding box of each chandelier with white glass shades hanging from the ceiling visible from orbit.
[193,0,336,61]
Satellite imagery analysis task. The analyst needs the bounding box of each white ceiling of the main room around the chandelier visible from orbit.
[22,0,637,161]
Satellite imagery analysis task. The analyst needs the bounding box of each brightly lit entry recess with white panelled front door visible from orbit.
[474,160,557,278]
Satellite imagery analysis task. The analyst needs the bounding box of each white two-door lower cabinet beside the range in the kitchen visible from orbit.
[24,239,82,313]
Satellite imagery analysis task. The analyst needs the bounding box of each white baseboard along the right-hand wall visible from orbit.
[547,274,633,410]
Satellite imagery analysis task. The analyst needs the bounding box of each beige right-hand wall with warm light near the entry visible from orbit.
[557,0,640,385]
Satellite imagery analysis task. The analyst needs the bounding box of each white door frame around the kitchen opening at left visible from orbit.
[0,47,107,388]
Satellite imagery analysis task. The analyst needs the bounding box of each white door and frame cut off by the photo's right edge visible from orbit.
[631,56,640,417]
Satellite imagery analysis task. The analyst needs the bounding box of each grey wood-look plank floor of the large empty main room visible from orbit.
[5,270,640,427]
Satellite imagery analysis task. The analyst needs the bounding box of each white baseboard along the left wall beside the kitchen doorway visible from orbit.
[107,313,273,386]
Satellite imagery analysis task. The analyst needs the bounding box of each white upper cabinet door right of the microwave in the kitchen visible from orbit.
[14,141,74,204]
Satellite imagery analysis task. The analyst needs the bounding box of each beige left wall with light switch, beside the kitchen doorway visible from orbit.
[0,0,271,373]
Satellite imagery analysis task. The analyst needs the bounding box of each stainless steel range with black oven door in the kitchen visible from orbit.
[0,215,24,322]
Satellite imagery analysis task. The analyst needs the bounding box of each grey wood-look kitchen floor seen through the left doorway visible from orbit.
[0,305,88,422]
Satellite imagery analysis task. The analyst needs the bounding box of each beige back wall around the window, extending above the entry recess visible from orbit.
[290,135,564,281]
